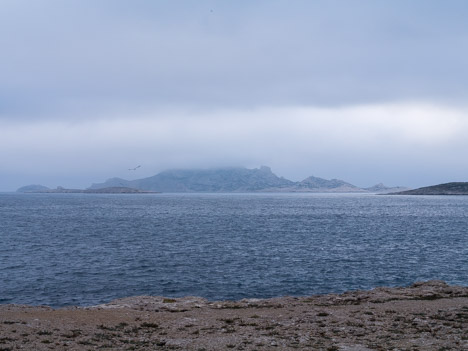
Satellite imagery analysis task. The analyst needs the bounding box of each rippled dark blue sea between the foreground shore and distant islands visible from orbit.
[0,194,468,306]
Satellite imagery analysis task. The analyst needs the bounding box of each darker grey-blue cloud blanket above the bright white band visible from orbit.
[0,1,468,118]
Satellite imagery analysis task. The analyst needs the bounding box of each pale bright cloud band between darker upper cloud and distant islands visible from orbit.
[0,104,468,190]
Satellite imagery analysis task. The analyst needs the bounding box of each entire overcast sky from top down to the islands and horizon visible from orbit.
[0,0,468,191]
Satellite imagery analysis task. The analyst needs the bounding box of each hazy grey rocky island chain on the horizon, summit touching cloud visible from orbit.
[17,166,408,193]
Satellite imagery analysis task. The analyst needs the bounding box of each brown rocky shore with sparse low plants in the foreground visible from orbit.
[0,281,468,351]
